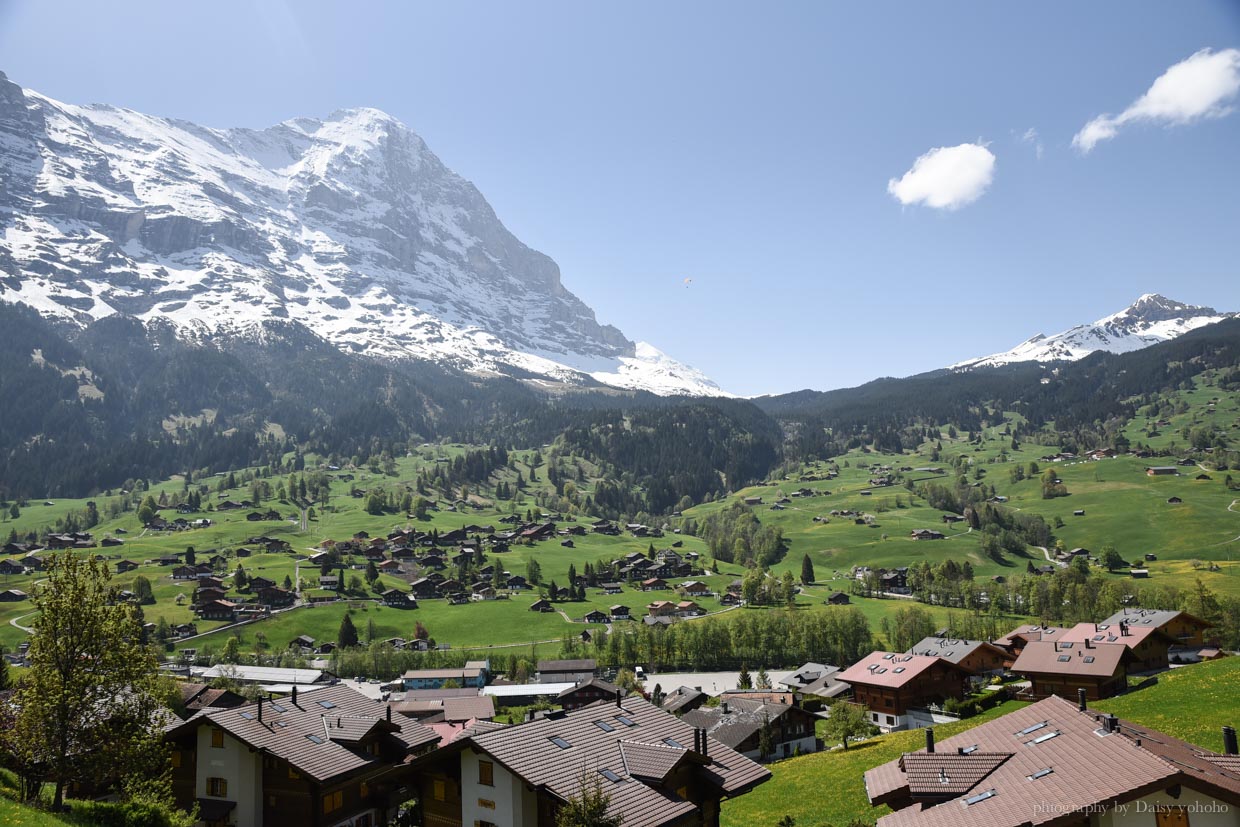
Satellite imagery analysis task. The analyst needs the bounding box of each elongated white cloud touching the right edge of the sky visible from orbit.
[1073,48,1240,153]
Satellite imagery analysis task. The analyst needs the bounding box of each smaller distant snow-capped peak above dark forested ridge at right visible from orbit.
[951,293,1238,371]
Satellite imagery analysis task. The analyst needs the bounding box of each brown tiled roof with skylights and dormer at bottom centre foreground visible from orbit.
[466,696,770,827]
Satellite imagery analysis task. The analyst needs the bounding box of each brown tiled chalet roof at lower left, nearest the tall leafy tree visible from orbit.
[169,684,439,781]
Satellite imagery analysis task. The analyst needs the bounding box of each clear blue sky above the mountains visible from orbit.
[0,0,1240,394]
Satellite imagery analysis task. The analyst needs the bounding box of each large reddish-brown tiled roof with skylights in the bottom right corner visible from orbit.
[866,696,1240,827]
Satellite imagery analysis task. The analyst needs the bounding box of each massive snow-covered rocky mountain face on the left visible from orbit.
[0,73,727,396]
